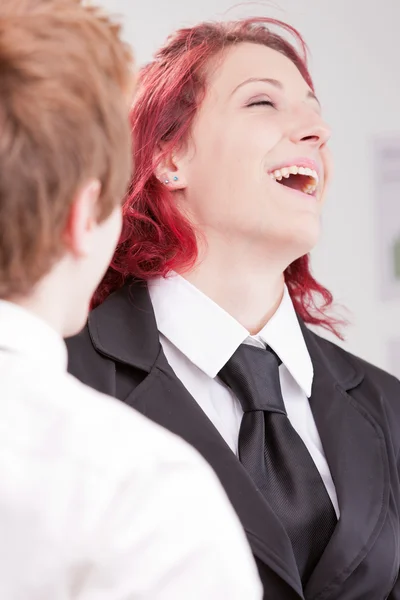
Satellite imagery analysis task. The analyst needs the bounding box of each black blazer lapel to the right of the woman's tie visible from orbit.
[303,326,389,600]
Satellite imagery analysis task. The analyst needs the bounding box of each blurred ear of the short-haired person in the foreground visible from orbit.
[64,179,101,258]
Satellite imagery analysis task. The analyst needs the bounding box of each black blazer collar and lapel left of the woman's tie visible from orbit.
[89,284,303,598]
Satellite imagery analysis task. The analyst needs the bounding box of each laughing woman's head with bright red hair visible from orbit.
[101,18,340,338]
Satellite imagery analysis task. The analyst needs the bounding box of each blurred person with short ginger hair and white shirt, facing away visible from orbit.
[0,0,262,600]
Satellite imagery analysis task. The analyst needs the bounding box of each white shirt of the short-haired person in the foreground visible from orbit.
[0,301,262,600]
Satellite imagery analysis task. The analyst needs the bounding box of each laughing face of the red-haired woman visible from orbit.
[175,43,330,264]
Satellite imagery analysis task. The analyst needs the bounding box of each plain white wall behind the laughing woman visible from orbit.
[102,0,400,375]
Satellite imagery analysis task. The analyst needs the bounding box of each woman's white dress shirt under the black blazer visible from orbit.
[149,273,339,517]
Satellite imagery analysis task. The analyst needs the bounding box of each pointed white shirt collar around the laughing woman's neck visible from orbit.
[149,273,313,397]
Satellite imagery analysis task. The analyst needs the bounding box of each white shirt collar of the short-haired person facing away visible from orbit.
[0,300,68,371]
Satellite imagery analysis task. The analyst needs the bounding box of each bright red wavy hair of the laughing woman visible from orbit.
[93,17,340,337]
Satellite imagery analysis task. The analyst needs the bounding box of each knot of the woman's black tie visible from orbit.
[218,344,286,414]
